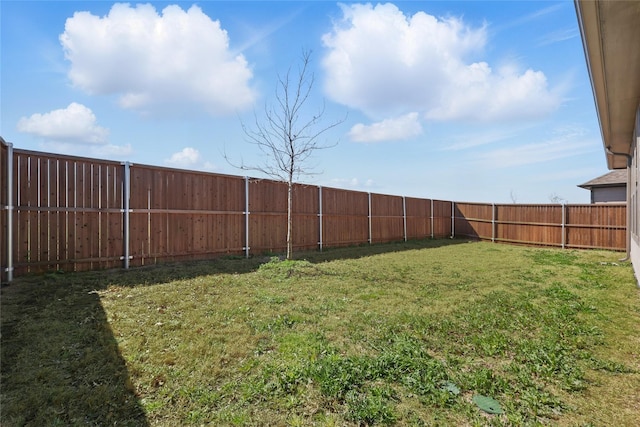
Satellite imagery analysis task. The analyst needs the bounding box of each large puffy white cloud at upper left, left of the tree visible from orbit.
[60,4,255,115]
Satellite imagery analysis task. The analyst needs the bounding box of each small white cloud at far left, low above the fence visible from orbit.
[17,102,109,144]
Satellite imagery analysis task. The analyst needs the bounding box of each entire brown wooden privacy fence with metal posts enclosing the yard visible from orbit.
[0,143,625,281]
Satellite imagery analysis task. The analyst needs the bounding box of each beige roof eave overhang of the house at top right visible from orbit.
[574,0,640,169]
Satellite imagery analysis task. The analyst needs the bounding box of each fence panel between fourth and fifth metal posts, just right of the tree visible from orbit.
[322,188,369,247]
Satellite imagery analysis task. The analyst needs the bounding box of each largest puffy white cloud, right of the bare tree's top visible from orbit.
[323,4,561,121]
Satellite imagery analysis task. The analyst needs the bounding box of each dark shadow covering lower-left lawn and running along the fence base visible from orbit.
[0,239,467,427]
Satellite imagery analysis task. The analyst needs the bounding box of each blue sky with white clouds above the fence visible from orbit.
[0,0,607,203]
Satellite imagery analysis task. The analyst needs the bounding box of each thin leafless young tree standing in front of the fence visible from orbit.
[225,51,346,259]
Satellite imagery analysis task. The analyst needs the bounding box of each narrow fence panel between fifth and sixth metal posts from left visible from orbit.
[371,193,404,243]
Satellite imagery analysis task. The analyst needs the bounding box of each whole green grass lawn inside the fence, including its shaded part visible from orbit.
[0,240,640,427]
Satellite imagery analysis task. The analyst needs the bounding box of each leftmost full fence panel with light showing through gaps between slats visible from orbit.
[13,150,123,275]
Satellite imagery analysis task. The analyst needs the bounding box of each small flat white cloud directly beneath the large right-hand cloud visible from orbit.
[349,112,422,142]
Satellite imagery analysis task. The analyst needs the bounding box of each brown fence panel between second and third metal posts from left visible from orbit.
[130,165,245,265]
